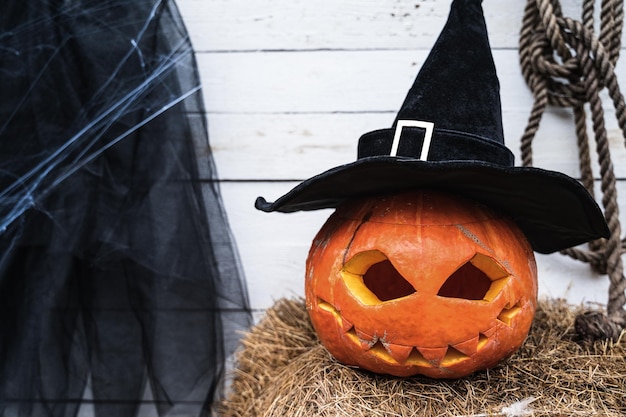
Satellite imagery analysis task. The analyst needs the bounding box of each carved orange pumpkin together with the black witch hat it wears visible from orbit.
[255,0,609,378]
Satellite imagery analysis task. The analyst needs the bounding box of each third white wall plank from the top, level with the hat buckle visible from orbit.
[208,109,626,181]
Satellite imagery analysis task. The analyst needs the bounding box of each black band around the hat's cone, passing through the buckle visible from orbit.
[357,120,515,167]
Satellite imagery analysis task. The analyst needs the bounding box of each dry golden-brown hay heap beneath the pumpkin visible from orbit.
[217,299,626,417]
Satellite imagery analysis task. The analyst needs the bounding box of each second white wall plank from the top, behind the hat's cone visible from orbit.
[198,50,536,113]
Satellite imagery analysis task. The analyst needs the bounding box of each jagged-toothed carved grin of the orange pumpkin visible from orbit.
[318,298,521,367]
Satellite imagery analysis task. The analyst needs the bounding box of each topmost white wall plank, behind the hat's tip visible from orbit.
[177,0,626,51]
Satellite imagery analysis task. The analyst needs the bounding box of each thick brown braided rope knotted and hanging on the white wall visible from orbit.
[519,0,626,338]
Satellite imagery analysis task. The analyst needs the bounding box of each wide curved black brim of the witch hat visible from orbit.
[255,156,609,253]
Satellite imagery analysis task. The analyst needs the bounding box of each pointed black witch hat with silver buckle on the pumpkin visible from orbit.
[255,0,609,253]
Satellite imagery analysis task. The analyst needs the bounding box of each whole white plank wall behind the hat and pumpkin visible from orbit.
[178,0,626,312]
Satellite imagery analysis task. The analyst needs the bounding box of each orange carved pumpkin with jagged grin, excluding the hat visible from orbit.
[305,191,537,378]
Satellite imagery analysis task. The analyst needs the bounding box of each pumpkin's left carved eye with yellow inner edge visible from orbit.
[341,250,415,305]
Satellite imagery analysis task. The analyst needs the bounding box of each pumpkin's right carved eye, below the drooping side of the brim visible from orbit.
[437,253,509,301]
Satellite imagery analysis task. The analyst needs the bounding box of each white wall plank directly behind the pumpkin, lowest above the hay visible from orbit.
[221,182,626,309]
